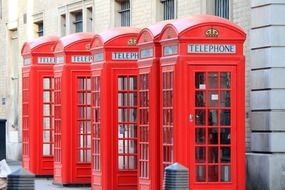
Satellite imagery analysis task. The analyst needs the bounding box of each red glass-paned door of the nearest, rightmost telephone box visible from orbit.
[188,66,237,189]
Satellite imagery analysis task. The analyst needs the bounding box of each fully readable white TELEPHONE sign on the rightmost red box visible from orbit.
[188,44,236,54]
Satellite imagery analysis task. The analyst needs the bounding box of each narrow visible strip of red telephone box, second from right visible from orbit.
[137,21,170,190]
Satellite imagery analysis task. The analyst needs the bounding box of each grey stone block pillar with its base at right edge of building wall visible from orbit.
[247,0,285,190]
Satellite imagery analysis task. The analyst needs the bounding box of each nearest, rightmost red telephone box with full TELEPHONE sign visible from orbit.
[160,16,246,190]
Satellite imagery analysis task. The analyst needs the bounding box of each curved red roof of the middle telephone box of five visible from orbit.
[91,27,140,49]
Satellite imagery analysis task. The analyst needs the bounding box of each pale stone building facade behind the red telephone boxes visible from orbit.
[0,0,285,190]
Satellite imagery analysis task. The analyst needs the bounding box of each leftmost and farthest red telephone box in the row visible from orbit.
[22,37,58,175]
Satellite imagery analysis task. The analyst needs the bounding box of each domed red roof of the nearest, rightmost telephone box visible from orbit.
[161,15,246,41]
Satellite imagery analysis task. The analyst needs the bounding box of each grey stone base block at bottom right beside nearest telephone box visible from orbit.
[246,153,285,190]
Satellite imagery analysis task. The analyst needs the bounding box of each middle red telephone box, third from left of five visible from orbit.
[91,28,140,190]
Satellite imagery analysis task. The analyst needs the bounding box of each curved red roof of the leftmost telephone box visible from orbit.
[21,36,59,56]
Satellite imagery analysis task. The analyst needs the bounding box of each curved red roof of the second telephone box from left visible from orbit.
[55,32,94,53]
